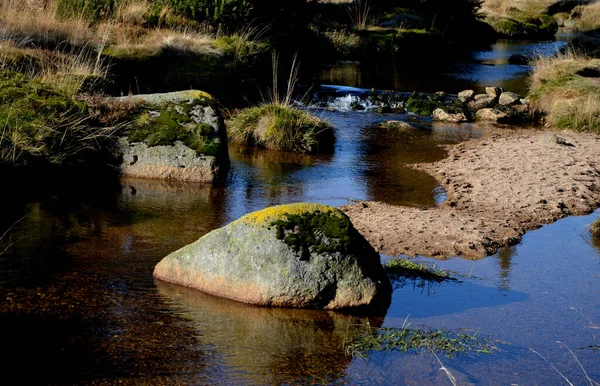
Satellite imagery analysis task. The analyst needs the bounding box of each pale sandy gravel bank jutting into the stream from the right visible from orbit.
[342,130,600,259]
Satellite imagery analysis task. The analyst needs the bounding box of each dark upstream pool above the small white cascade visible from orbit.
[313,35,569,95]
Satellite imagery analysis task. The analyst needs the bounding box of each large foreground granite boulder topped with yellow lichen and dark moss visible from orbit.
[154,203,391,309]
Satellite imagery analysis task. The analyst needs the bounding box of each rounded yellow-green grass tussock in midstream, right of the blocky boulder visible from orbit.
[228,104,335,153]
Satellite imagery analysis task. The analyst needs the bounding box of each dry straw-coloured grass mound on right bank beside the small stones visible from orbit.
[529,53,600,133]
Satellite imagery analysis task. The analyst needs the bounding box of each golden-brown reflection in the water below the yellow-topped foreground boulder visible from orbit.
[156,281,382,385]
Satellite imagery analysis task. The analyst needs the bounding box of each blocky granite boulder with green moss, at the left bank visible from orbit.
[112,90,229,182]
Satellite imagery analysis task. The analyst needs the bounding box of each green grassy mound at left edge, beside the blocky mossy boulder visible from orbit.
[0,71,110,166]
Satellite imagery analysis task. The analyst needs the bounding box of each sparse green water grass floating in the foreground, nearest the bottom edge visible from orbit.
[346,326,497,358]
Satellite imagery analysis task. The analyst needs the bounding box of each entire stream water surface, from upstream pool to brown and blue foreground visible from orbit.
[0,37,600,385]
